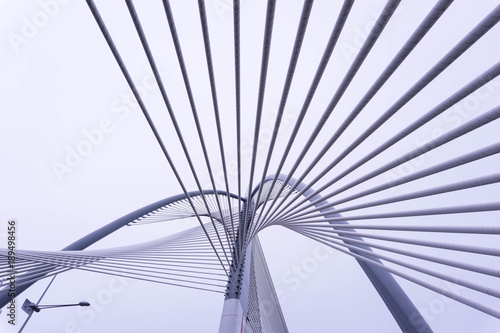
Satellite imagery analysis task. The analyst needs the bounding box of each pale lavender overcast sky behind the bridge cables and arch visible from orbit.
[0,0,500,333]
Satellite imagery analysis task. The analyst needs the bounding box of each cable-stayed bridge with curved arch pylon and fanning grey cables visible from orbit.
[0,0,500,332]
